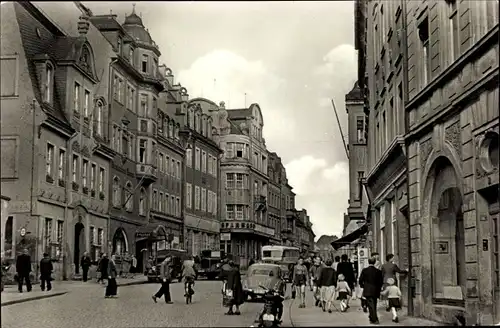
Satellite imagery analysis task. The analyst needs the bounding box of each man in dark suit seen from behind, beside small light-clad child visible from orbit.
[359,257,384,324]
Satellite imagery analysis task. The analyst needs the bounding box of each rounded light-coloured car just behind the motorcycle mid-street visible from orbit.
[243,263,282,300]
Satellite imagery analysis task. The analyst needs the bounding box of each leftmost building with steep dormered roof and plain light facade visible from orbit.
[1,2,112,279]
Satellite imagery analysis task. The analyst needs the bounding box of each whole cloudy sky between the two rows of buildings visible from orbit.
[83,1,357,238]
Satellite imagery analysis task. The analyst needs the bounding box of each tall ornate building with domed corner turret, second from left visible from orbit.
[91,10,184,272]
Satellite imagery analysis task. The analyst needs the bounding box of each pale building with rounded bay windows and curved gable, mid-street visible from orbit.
[212,103,275,266]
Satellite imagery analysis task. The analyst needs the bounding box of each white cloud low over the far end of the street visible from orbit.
[286,156,349,237]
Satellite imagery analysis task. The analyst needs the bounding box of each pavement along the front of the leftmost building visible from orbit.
[1,276,147,306]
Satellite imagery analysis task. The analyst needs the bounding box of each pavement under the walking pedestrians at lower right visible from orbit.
[282,298,444,327]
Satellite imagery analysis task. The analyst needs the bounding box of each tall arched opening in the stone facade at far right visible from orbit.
[429,157,467,305]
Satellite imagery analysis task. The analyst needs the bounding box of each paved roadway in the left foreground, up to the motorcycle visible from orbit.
[1,281,262,328]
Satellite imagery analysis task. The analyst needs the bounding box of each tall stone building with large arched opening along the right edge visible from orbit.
[356,0,500,325]
